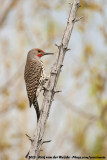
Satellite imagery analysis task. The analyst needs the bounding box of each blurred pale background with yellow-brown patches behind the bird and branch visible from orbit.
[0,0,107,160]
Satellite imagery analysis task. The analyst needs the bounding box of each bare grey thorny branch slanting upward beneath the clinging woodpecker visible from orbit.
[26,0,80,160]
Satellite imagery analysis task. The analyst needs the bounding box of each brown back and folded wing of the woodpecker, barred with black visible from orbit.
[24,59,42,107]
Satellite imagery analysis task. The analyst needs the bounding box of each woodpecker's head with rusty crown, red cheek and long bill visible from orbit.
[29,48,53,58]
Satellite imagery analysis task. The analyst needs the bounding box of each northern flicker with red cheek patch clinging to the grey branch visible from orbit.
[24,48,53,121]
